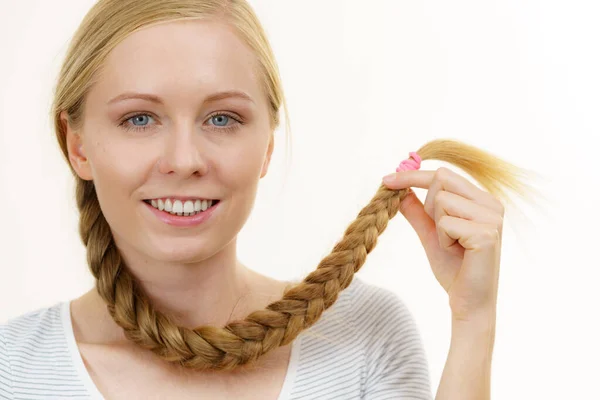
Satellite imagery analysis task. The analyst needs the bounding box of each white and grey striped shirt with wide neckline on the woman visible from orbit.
[0,276,432,400]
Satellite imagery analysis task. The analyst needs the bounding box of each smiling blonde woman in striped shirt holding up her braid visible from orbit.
[0,0,516,400]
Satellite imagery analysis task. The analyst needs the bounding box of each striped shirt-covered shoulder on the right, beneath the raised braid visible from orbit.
[292,276,428,398]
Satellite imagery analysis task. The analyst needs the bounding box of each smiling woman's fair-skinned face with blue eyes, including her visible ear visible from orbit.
[67,21,273,262]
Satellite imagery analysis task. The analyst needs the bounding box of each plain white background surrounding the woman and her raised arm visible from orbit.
[0,0,600,399]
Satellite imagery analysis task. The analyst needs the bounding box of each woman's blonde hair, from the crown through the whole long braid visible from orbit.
[52,0,536,370]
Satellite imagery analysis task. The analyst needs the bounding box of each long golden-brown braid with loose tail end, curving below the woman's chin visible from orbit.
[71,140,526,371]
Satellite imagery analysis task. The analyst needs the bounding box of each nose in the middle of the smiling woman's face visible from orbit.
[159,123,208,178]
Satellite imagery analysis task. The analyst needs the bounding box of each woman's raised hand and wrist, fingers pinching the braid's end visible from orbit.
[383,167,504,324]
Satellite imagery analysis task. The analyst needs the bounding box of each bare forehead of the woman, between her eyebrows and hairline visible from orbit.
[96,20,260,99]
